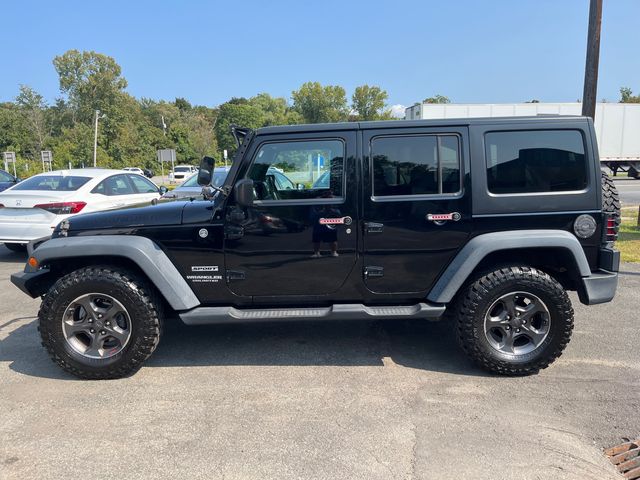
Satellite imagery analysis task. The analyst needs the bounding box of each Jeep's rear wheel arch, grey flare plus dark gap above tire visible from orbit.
[427,230,591,303]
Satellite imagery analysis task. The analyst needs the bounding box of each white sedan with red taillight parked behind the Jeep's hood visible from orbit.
[0,168,166,251]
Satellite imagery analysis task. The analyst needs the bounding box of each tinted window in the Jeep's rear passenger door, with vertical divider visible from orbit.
[371,135,460,197]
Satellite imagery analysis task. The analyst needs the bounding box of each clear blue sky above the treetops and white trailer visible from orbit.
[0,0,640,112]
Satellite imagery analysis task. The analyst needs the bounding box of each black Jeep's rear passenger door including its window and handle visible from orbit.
[363,126,471,294]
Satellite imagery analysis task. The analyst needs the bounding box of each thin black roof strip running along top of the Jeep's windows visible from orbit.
[256,115,588,135]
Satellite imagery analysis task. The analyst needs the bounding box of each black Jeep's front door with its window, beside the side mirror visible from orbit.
[225,131,358,296]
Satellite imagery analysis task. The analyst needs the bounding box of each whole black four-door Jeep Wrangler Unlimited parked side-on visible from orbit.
[12,117,619,379]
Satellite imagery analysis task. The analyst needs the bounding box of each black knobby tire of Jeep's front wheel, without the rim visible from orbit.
[38,266,162,380]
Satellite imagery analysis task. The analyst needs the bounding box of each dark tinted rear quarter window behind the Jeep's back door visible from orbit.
[485,130,587,193]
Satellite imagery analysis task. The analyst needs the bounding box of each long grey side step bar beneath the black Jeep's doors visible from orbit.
[179,303,445,325]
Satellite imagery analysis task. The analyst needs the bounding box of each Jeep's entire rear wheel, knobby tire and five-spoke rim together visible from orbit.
[456,266,573,375]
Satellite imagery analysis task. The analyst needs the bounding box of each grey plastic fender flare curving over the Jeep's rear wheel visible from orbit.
[427,230,591,303]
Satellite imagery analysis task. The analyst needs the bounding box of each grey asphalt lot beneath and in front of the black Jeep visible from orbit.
[0,246,640,480]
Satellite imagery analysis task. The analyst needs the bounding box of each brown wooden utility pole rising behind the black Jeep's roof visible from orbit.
[582,0,602,118]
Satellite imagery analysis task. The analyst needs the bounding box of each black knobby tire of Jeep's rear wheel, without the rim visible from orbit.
[453,266,573,376]
